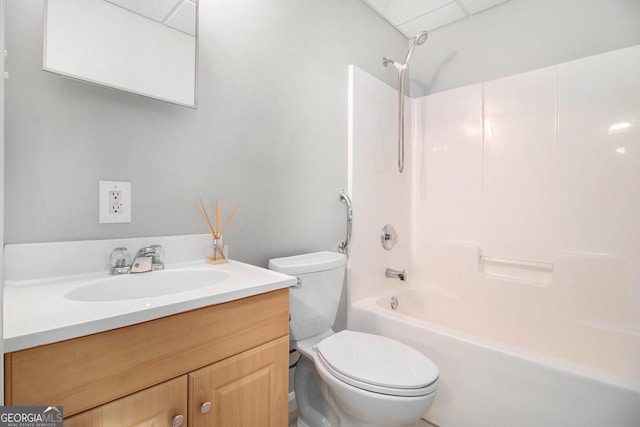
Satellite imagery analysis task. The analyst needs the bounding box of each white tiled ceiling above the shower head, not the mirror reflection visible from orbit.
[363,0,508,39]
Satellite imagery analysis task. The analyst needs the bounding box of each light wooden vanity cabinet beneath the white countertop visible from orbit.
[5,289,289,427]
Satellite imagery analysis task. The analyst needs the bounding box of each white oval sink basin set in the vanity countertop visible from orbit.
[64,268,229,302]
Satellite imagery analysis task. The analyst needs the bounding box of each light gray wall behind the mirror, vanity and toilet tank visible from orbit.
[5,0,407,265]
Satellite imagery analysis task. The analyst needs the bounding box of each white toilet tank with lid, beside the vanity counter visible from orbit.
[269,252,347,341]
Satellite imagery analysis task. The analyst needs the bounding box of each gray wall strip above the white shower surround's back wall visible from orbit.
[410,0,640,97]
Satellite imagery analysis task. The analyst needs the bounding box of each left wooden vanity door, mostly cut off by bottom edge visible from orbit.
[64,375,188,427]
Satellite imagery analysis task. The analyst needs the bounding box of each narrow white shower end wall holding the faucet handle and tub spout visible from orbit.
[348,66,413,300]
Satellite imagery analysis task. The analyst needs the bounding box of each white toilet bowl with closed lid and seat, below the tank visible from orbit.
[294,331,438,427]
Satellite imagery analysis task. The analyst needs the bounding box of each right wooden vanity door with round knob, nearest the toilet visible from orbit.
[189,336,289,427]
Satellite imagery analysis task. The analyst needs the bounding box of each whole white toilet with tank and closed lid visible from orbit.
[269,252,438,427]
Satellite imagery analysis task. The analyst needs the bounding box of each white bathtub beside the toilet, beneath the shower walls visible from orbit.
[348,288,640,427]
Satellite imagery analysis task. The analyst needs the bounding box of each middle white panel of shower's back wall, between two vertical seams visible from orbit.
[480,67,556,262]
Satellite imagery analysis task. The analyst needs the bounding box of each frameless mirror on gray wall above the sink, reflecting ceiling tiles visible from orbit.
[43,0,198,108]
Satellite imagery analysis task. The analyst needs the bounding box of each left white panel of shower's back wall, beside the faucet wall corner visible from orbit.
[412,84,483,282]
